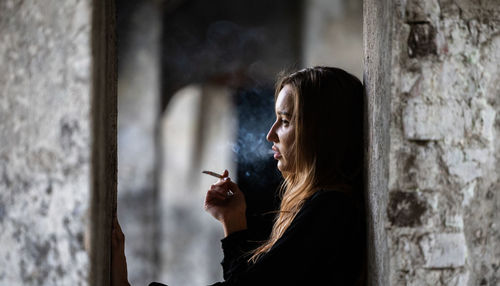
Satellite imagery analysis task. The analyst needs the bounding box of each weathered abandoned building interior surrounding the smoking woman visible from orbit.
[0,0,500,286]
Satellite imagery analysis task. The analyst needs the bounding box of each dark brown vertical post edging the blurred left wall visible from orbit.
[89,0,117,286]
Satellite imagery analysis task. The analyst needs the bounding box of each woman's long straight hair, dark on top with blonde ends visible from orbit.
[249,67,363,263]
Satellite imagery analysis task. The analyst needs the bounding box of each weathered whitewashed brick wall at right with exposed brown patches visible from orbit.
[387,0,500,286]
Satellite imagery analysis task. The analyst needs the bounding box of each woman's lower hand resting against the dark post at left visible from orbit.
[111,214,130,286]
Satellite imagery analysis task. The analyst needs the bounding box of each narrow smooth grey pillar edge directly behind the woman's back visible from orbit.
[363,0,393,286]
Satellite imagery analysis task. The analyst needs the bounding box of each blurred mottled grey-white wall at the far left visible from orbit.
[0,0,91,285]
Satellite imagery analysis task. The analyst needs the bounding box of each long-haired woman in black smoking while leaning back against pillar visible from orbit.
[113,67,366,286]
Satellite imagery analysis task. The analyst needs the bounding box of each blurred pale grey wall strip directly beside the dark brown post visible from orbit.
[116,1,162,285]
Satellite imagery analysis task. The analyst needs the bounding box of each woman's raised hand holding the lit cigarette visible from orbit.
[205,170,247,236]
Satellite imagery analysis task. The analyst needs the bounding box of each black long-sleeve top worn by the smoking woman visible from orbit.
[152,190,366,286]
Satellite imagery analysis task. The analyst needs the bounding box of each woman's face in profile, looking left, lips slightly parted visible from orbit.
[266,85,295,173]
